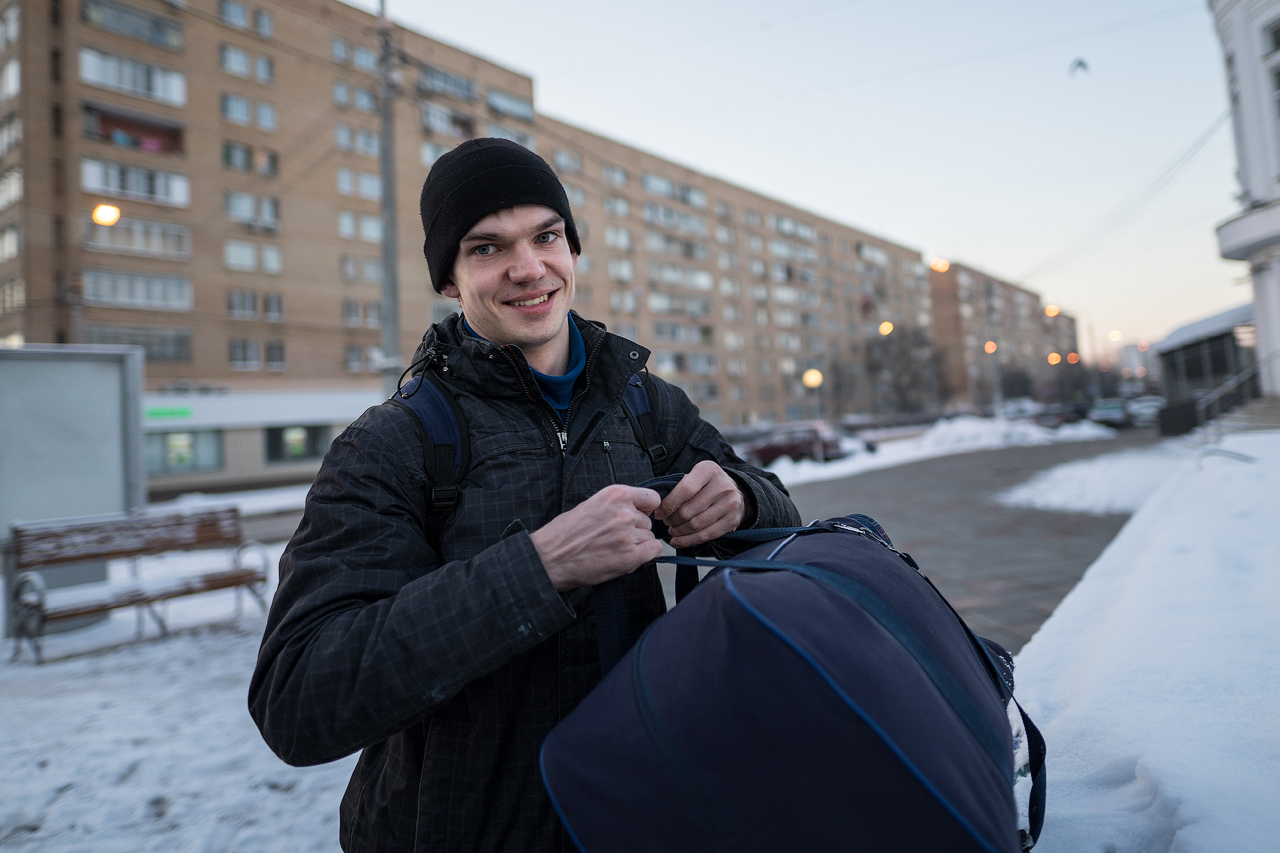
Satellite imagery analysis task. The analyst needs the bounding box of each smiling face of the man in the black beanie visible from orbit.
[440,205,577,356]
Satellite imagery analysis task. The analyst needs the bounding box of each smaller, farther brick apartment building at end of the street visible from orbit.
[929,261,1079,410]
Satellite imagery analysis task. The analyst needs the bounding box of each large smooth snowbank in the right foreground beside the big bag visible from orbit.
[1018,432,1280,853]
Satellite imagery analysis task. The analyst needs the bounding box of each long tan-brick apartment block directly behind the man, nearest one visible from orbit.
[0,0,1064,488]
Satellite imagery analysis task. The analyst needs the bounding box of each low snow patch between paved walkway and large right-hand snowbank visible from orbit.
[996,441,1194,515]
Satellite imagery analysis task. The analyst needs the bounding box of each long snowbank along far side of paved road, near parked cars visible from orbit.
[768,415,1115,485]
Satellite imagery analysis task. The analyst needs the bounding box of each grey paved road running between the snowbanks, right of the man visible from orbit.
[791,429,1158,652]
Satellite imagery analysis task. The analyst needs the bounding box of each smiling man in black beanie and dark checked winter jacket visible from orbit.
[250,140,799,852]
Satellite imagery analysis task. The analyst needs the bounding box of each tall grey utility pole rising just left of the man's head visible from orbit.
[378,0,403,397]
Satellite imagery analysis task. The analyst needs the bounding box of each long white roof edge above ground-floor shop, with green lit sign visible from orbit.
[142,389,385,433]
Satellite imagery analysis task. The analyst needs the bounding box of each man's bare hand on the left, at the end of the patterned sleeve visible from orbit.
[529,485,662,592]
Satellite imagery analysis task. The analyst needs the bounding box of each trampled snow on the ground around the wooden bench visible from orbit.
[0,543,356,853]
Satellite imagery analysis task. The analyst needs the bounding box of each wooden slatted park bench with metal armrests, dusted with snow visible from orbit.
[9,507,270,663]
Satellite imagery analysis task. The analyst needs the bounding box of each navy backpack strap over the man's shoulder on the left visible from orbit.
[392,370,471,517]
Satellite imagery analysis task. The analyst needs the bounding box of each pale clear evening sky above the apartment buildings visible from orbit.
[355,0,1252,356]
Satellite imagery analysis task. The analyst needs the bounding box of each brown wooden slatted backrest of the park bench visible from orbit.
[13,507,243,571]
